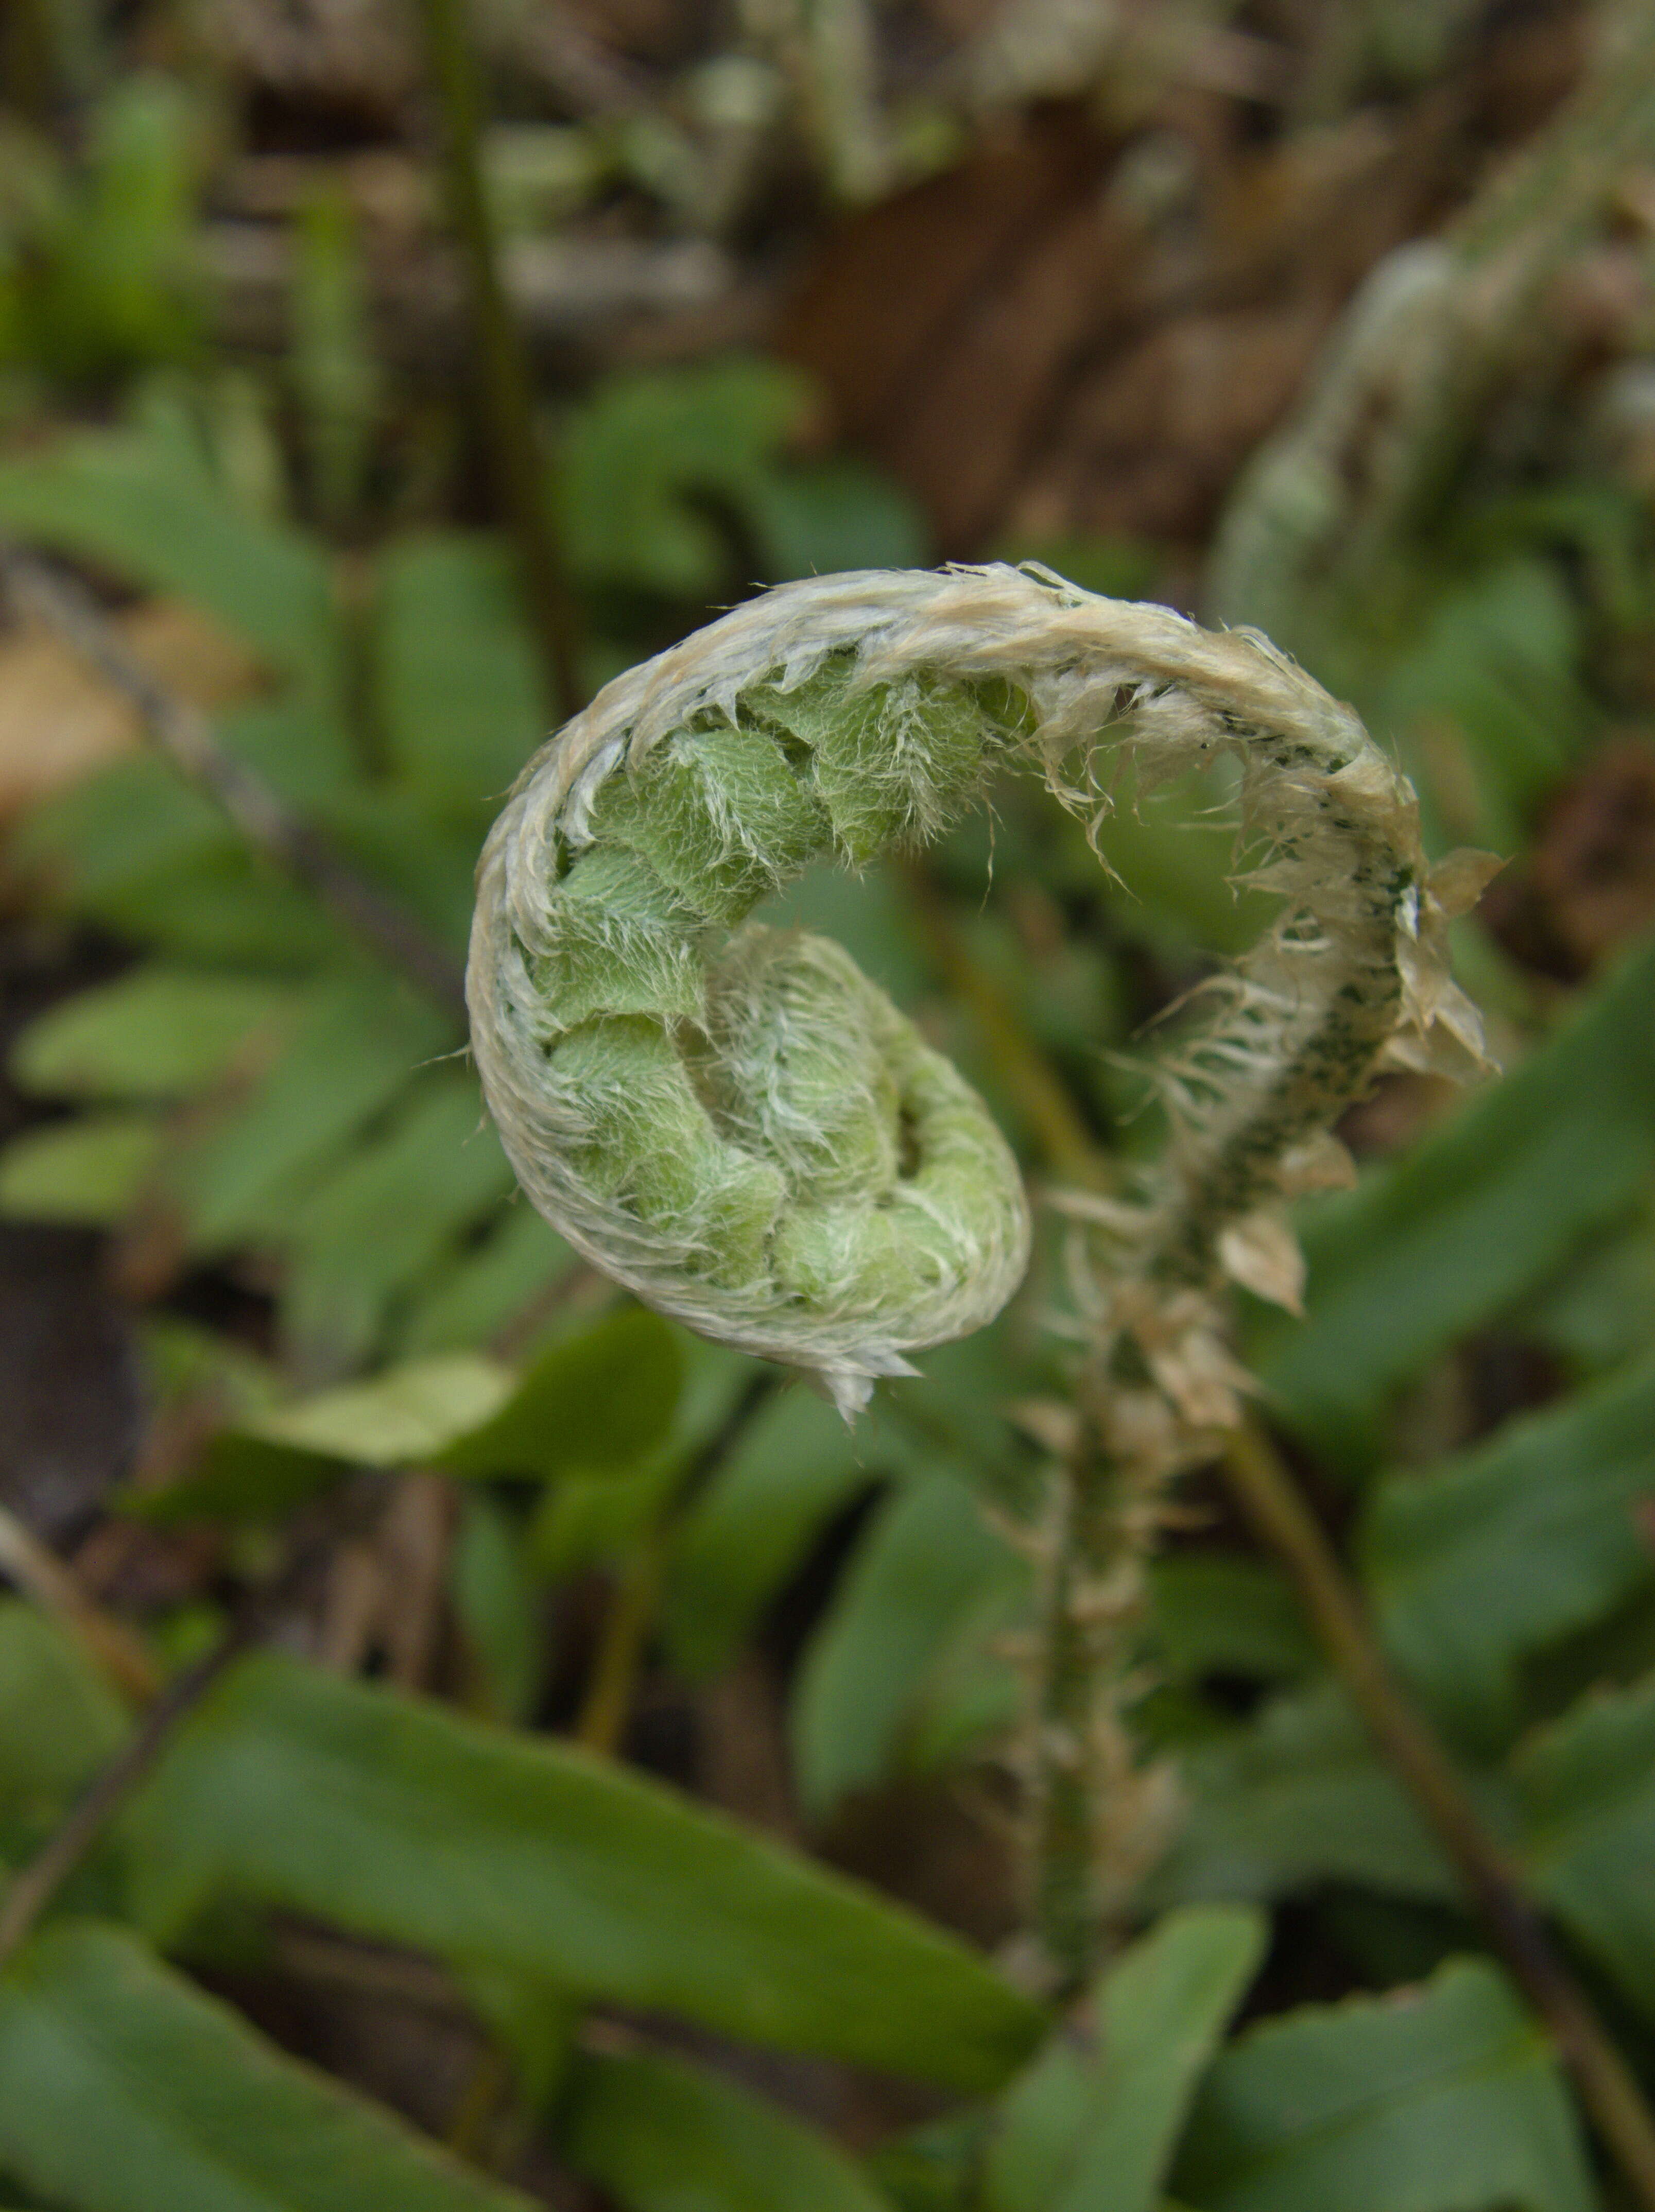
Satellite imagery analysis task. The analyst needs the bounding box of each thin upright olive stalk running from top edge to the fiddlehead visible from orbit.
[420,0,582,721]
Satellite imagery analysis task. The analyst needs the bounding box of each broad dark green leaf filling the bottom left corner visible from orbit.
[0,1920,529,2212]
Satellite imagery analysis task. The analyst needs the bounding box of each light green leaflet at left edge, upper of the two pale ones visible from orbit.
[11,964,294,1099]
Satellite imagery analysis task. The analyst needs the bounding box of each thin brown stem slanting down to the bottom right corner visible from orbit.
[1223,1422,1655,2207]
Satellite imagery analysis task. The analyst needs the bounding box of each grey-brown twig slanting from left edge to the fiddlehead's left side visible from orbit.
[0,546,464,1019]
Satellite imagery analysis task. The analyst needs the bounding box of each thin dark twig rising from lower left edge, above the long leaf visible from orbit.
[0,1475,385,1966]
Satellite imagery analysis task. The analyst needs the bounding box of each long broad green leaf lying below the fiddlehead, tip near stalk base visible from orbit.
[126,1657,1042,2088]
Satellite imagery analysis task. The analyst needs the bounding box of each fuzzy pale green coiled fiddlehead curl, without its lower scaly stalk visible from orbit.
[469,566,1480,1411]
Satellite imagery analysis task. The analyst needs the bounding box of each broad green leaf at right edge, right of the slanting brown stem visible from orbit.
[1361,1365,1655,1748]
